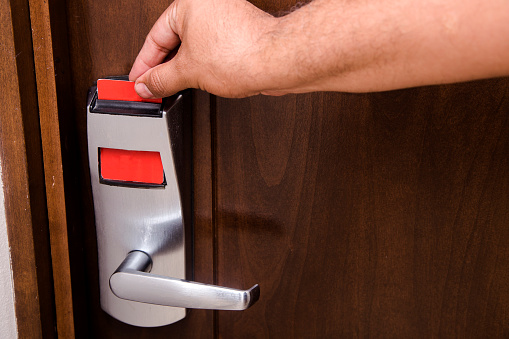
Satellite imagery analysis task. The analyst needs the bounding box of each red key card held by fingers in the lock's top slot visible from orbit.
[97,79,163,104]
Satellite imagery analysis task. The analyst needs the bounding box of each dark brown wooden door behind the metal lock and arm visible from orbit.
[26,0,509,338]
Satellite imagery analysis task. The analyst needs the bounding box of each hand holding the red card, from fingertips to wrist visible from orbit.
[129,0,277,98]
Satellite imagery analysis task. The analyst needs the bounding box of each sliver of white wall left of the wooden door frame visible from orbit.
[0,159,18,339]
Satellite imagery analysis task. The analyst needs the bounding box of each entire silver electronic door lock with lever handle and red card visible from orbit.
[87,78,260,327]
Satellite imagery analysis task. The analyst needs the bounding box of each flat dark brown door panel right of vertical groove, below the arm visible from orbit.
[215,79,509,338]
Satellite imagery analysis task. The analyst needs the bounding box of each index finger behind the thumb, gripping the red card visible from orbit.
[129,1,180,81]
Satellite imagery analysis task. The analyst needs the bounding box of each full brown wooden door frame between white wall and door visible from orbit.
[0,0,82,338]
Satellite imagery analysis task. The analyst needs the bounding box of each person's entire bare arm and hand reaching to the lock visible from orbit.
[129,0,509,98]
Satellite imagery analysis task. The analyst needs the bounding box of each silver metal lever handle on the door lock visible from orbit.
[110,251,260,311]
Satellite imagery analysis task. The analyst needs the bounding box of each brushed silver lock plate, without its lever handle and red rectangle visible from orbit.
[87,88,186,327]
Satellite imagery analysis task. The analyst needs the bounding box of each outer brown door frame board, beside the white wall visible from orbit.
[0,0,56,338]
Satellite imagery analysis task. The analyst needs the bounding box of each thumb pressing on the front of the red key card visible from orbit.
[134,57,189,99]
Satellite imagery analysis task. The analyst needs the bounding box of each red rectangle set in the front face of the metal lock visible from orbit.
[99,148,164,185]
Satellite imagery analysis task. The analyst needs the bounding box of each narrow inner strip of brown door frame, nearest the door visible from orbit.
[29,0,76,338]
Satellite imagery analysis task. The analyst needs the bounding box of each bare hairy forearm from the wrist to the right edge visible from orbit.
[254,0,509,94]
